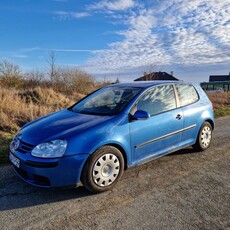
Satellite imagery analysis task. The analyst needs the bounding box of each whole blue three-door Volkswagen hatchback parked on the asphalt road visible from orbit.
[9,81,214,193]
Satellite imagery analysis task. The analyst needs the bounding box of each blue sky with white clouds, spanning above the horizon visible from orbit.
[0,0,230,82]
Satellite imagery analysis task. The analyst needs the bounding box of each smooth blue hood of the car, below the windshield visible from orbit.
[18,109,113,145]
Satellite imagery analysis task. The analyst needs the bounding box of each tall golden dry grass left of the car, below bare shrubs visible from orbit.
[0,86,79,132]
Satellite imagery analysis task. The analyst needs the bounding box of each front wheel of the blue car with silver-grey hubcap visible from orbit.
[81,146,124,193]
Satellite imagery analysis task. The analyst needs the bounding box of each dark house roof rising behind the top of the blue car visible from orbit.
[134,72,178,81]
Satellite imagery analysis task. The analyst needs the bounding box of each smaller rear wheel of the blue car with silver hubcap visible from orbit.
[193,121,212,151]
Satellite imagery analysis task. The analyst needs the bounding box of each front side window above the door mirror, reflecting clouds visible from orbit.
[137,85,176,116]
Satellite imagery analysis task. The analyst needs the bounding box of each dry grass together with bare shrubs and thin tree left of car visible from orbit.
[0,59,113,134]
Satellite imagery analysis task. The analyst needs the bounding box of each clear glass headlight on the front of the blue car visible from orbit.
[31,140,67,158]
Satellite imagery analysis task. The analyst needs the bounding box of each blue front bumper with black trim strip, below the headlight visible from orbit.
[10,151,88,188]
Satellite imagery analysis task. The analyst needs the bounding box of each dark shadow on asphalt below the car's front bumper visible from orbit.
[0,166,93,211]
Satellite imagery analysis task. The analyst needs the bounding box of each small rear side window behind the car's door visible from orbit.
[176,84,199,106]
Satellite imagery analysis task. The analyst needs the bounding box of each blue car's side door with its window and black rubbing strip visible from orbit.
[129,84,183,165]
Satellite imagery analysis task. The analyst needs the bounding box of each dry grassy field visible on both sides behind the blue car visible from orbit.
[0,85,230,164]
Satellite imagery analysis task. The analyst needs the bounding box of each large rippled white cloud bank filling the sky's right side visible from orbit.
[87,0,230,73]
